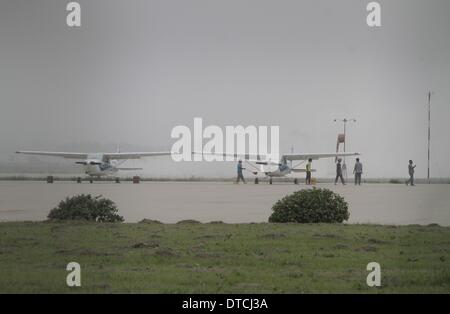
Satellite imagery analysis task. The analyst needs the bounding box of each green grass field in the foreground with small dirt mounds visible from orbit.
[0,222,450,293]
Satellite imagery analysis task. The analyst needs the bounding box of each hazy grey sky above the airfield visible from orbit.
[0,0,450,177]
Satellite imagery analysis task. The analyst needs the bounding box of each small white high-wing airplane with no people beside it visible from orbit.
[16,151,171,177]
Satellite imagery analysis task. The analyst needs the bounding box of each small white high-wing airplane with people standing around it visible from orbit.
[194,152,360,184]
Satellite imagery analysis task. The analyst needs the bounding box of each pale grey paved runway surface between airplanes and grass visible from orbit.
[0,181,450,226]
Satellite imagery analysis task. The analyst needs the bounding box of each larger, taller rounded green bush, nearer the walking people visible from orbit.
[269,188,350,223]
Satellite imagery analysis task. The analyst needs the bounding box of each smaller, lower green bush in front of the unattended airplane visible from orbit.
[48,194,123,222]
